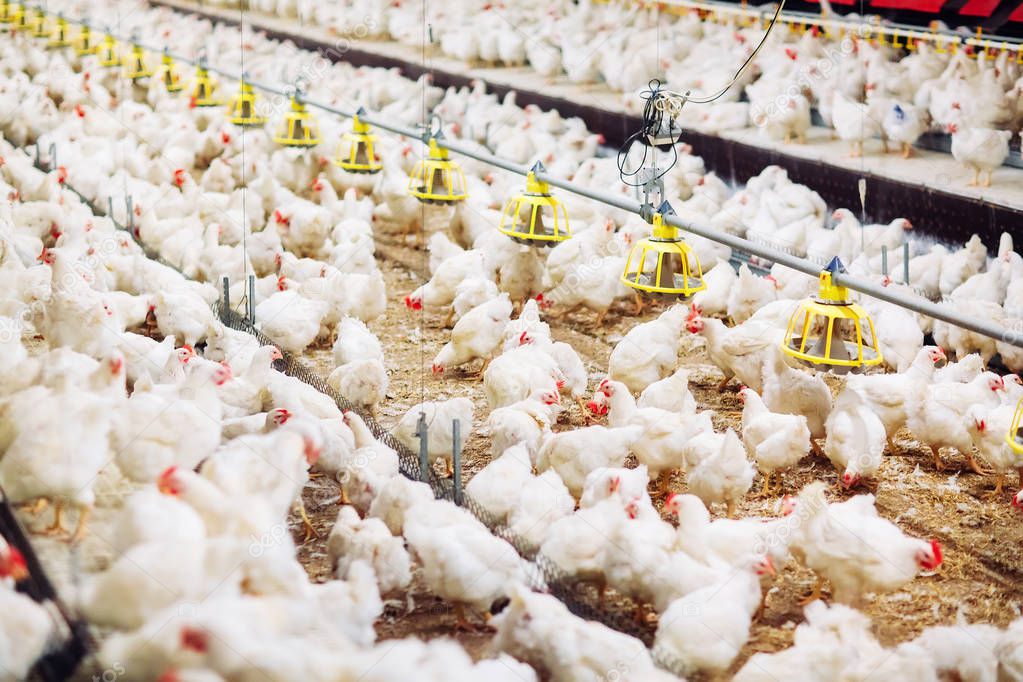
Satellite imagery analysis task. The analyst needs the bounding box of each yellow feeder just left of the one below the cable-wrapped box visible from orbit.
[497,162,572,246]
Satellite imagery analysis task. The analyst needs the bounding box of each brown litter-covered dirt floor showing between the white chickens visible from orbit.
[282,217,1023,679]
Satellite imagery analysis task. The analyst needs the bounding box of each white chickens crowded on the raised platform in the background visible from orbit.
[224,0,1023,185]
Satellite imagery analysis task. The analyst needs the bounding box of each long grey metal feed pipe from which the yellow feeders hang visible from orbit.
[36,12,1023,348]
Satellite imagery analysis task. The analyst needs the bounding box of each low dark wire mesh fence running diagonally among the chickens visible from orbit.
[214,302,695,674]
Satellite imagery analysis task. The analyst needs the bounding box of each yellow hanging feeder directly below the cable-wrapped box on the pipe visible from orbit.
[622,201,707,298]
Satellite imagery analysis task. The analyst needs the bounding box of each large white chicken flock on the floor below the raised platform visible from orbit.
[0,2,1023,681]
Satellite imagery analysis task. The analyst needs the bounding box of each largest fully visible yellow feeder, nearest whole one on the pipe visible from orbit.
[782,258,884,374]
